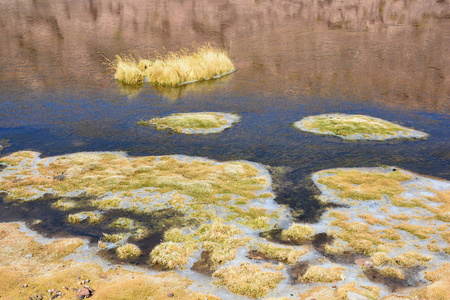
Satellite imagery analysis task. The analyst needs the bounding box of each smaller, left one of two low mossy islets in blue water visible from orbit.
[137,112,240,134]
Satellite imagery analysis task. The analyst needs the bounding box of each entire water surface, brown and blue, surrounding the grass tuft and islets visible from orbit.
[0,0,450,232]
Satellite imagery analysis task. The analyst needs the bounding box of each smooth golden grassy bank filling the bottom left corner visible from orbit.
[0,223,219,300]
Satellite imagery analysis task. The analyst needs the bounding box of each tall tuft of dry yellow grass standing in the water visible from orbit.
[111,45,235,86]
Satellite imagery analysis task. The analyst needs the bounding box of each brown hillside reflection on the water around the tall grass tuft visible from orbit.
[0,0,450,110]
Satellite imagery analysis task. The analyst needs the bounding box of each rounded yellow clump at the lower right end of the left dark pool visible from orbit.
[150,242,195,269]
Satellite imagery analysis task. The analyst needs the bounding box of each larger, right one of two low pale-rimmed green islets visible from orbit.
[294,114,428,140]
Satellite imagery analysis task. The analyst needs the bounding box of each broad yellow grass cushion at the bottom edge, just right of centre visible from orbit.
[213,263,284,298]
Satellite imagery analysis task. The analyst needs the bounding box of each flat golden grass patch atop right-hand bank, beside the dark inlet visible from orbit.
[317,170,411,200]
